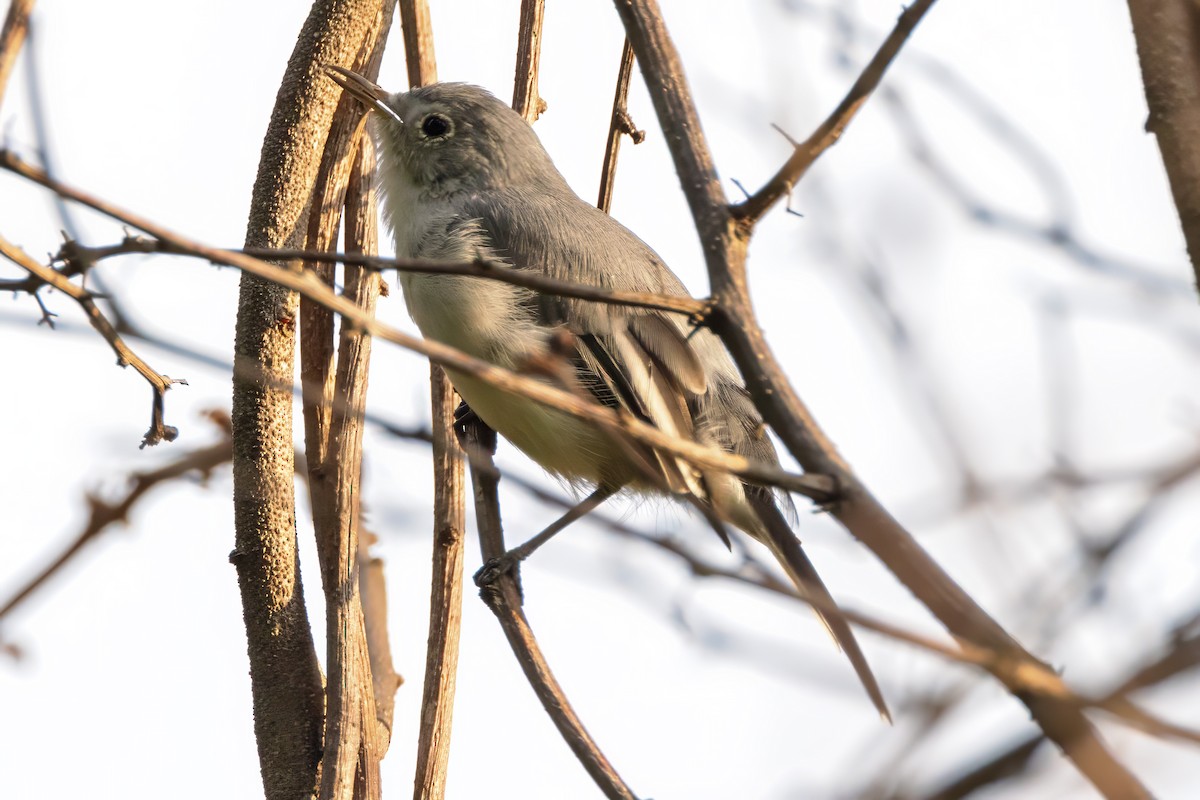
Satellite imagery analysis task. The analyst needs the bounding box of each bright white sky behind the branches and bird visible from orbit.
[0,0,1200,800]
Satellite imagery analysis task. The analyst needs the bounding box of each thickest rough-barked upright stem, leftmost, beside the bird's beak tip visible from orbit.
[229,0,398,800]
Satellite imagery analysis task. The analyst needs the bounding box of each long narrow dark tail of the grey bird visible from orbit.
[745,486,892,724]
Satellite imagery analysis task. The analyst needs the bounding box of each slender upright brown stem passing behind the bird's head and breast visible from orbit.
[400,6,467,800]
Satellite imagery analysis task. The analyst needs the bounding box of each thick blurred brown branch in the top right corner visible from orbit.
[1129,0,1200,293]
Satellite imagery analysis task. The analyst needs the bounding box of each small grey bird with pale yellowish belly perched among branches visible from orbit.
[329,67,888,716]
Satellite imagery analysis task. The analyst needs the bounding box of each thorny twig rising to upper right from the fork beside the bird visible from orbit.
[732,0,934,228]
